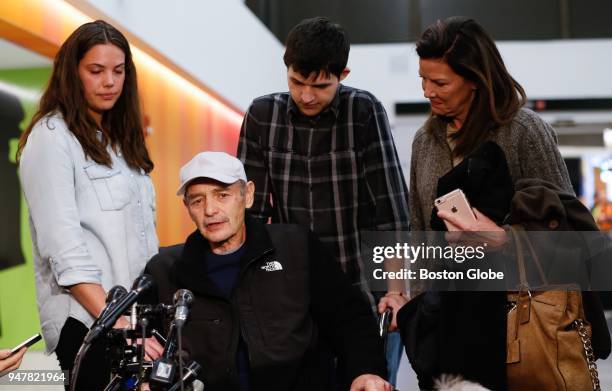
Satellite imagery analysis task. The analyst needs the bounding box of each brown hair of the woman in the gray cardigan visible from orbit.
[416,16,527,156]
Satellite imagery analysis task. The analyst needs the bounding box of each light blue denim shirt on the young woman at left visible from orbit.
[20,114,159,353]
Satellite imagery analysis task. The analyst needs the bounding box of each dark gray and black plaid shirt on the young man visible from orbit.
[238,85,409,283]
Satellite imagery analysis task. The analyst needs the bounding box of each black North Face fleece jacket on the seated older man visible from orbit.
[145,218,386,391]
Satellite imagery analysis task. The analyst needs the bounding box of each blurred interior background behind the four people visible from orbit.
[0,0,612,390]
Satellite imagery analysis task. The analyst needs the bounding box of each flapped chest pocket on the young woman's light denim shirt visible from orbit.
[83,163,130,210]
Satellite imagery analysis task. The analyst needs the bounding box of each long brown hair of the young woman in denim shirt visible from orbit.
[17,20,153,172]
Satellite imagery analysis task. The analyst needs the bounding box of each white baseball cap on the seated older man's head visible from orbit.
[176,152,247,196]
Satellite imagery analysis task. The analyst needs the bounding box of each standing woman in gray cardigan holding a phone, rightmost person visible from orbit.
[379,17,573,390]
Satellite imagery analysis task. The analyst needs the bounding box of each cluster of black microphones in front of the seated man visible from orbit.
[71,275,202,391]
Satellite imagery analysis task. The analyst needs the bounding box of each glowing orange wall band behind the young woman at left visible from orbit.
[0,0,242,245]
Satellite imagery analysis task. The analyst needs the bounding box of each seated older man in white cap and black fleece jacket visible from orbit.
[145,152,391,391]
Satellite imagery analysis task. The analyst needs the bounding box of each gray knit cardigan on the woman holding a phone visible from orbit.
[410,108,574,231]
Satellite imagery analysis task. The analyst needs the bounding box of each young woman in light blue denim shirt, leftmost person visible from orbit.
[17,20,161,390]
